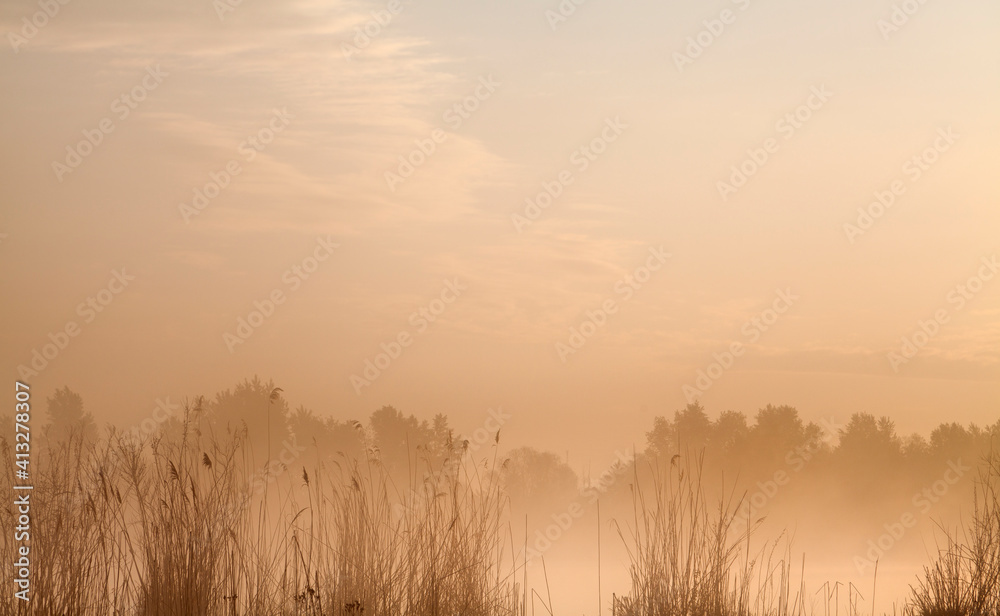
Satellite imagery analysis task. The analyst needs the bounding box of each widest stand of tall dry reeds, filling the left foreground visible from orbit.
[0,404,524,616]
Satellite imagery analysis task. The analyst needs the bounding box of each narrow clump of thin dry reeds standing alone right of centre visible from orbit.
[613,457,804,616]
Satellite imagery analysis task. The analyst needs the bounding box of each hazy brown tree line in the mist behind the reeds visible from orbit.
[9,377,1000,524]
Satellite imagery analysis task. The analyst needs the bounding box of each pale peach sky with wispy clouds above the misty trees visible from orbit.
[0,0,1000,464]
